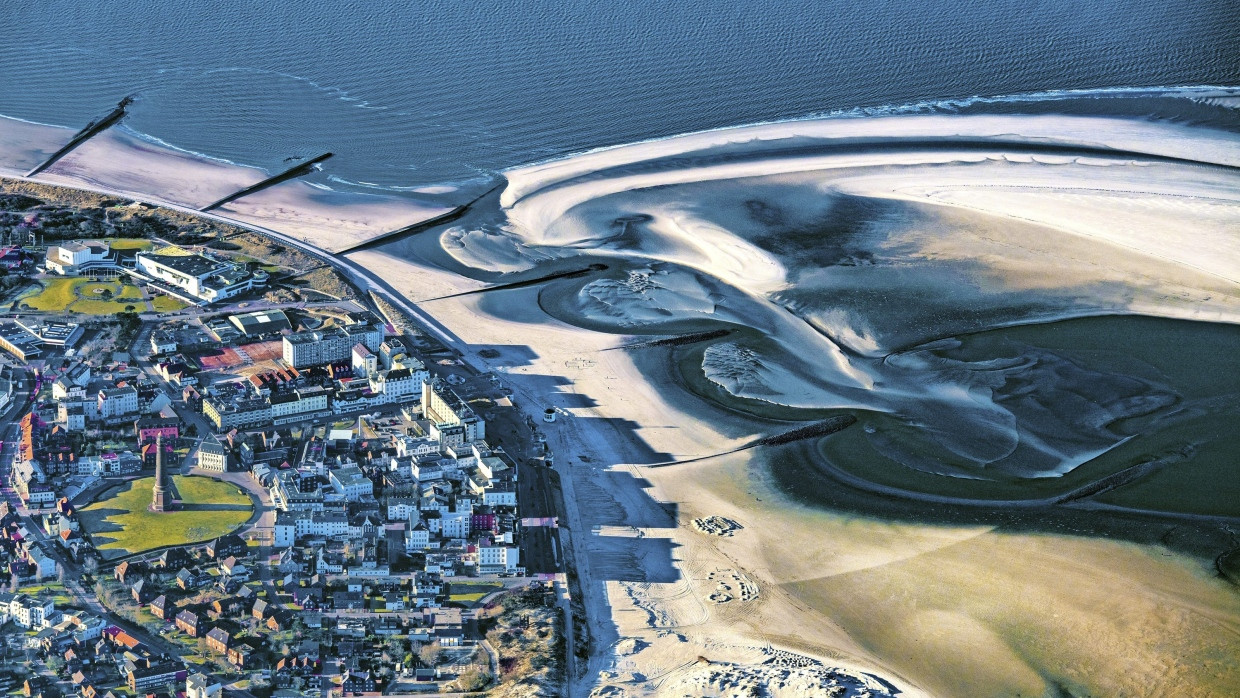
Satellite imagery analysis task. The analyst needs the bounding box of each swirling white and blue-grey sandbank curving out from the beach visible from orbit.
[443,115,1240,479]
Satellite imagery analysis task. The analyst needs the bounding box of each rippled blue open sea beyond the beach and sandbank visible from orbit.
[0,0,1240,197]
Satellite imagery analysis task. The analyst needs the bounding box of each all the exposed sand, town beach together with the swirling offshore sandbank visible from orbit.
[0,106,1240,697]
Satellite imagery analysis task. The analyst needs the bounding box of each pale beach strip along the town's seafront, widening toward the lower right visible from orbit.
[2,105,1240,696]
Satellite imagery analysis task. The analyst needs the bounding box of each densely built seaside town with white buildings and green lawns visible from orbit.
[0,185,567,698]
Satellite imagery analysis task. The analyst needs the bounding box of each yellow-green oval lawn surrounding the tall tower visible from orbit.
[79,475,254,557]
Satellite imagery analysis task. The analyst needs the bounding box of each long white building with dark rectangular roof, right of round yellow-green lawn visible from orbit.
[135,247,267,305]
